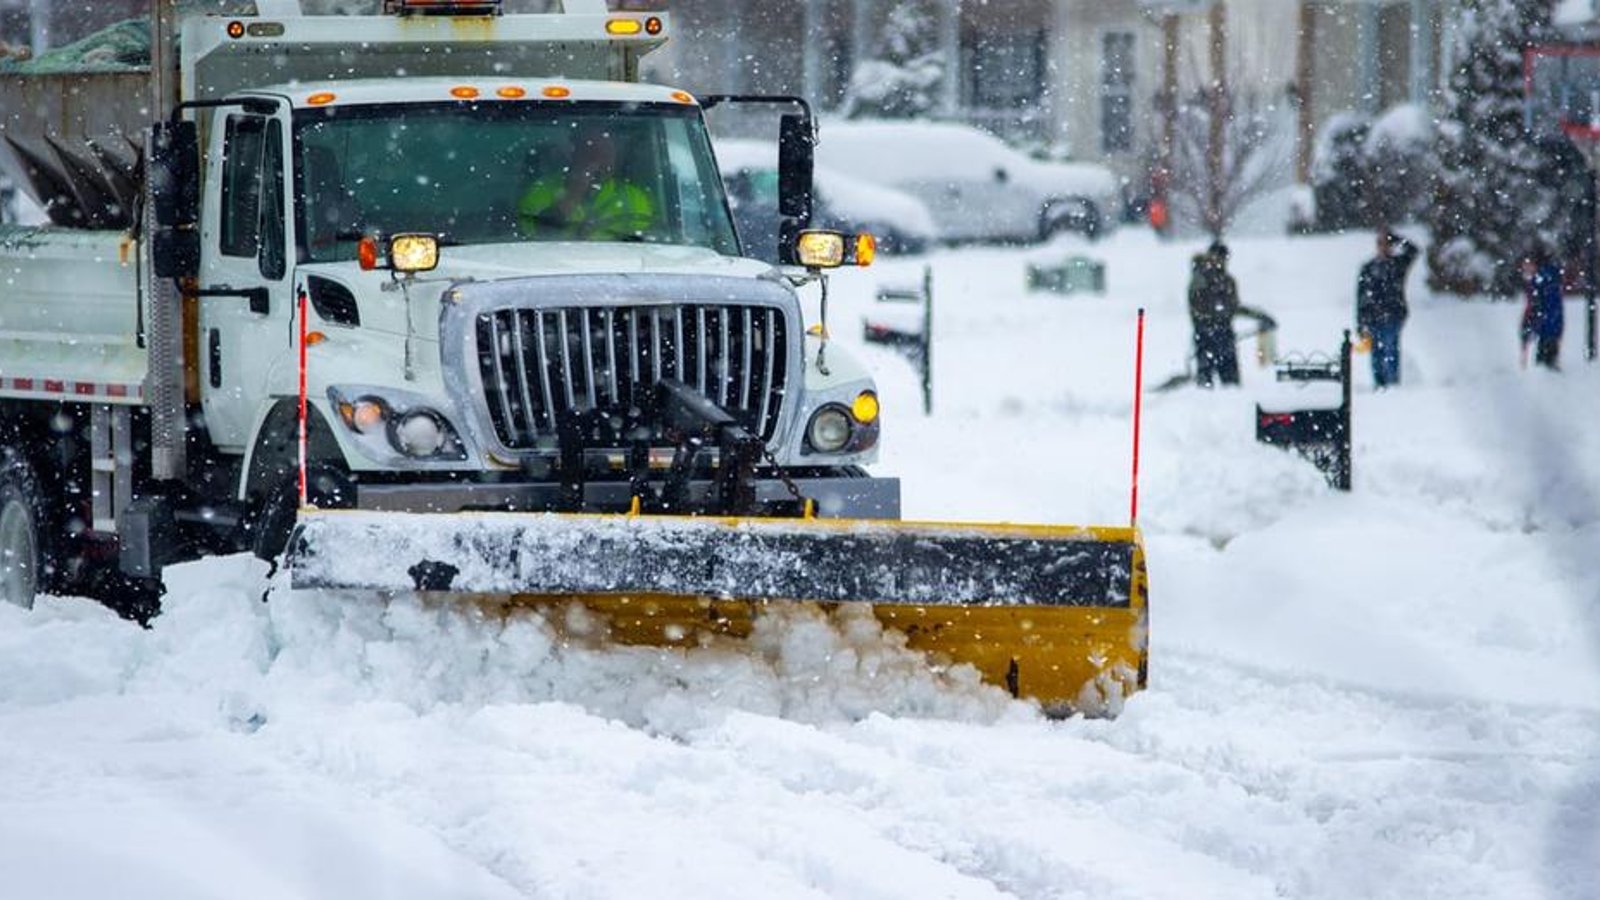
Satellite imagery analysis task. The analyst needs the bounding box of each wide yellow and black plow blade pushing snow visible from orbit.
[290,509,1147,716]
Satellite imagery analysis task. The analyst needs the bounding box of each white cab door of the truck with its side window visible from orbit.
[200,109,293,450]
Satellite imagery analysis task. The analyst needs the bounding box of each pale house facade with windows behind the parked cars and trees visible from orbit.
[646,0,1451,185]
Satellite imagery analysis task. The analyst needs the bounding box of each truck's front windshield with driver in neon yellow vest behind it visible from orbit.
[294,102,738,263]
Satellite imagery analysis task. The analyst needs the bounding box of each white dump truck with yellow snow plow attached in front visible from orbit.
[0,0,1147,714]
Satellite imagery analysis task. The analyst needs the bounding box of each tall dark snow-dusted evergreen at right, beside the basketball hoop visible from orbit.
[1427,0,1566,295]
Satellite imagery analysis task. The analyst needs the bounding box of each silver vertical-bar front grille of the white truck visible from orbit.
[477,304,787,450]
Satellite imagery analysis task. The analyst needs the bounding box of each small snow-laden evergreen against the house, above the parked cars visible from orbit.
[840,0,949,119]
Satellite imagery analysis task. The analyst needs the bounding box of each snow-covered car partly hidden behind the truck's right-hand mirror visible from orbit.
[715,139,934,263]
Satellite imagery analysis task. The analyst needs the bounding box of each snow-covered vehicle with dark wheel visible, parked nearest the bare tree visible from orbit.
[816,122,1120,243]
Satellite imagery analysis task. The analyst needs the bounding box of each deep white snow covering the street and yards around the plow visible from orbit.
[0,232,1600,900]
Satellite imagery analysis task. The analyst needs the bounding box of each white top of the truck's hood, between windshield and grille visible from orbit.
[296,243,774,340]
